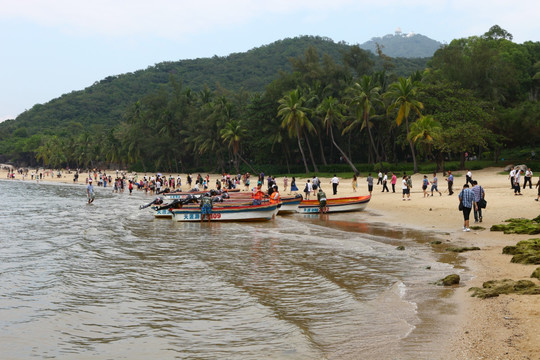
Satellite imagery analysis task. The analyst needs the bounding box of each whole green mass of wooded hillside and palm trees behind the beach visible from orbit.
[0,26,540,172]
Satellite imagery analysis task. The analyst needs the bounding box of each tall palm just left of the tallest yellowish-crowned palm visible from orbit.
[343,75,382,167]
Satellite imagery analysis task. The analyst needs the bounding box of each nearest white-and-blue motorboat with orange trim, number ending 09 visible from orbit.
[170,203,279,221]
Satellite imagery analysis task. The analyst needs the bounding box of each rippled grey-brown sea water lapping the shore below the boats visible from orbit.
[0,180,459,359]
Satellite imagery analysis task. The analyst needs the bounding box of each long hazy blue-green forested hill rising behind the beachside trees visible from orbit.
[0,36,427,136]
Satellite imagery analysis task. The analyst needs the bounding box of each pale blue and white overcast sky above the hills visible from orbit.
[0,0,540,121]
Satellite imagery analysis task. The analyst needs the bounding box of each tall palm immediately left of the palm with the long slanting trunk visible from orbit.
[278,89,313,174]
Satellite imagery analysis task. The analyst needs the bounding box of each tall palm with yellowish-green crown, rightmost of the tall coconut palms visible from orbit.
[385,77,424,173]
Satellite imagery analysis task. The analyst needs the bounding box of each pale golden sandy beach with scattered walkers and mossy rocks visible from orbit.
[4,168,540,359]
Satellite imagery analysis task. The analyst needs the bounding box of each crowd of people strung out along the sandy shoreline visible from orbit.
[7,166,540,226]
